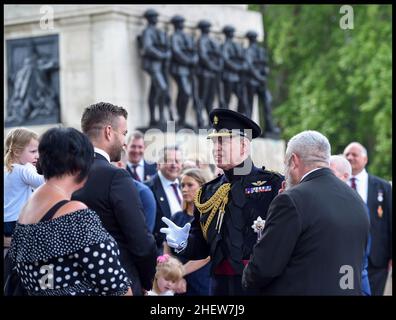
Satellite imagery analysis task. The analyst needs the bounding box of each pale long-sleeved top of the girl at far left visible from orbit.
[4,162,44,222]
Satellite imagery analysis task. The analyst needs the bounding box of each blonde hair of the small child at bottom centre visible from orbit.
[153,254,184,293]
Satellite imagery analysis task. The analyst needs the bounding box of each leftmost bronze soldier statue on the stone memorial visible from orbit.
[139,9,173,127]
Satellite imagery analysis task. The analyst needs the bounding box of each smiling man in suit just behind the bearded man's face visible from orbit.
[126,131,157,182]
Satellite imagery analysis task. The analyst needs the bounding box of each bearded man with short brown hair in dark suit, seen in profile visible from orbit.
[73,102,157,295]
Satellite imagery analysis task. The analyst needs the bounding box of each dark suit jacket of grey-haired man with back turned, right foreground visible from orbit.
[243,168,369,295]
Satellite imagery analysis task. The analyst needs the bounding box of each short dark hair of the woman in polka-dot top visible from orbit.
[37,128,94,183]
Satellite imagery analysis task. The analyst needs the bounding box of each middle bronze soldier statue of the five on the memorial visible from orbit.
[197,20,223,123]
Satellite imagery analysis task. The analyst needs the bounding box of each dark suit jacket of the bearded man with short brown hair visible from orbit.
[73,153,156,295]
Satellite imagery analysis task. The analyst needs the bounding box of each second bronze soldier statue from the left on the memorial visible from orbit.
[170,15,202,128]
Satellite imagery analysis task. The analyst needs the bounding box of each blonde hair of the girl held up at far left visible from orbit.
[4,128,38,172]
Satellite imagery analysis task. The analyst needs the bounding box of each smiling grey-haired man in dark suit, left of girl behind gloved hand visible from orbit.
[146,146,183,254]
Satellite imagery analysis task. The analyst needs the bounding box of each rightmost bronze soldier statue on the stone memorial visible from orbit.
[246,31,280,134]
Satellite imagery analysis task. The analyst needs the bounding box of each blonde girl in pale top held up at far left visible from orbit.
[4,128,44,240]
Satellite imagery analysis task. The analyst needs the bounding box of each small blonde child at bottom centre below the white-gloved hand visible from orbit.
[147,254,184,296]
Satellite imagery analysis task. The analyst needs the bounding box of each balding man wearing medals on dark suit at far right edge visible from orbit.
[344,142,392,296]
